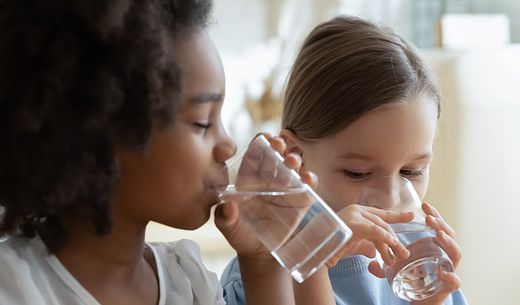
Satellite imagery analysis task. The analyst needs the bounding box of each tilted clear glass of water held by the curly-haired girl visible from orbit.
[213,135,352,283]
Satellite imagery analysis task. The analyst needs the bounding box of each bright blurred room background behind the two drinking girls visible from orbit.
[147,0,520,305]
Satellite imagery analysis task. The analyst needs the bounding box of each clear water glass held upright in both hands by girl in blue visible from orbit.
[360,177,453,301]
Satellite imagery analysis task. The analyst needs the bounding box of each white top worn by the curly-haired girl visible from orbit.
[0,237,225,305]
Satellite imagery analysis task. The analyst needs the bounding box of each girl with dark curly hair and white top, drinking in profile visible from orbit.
[0,0,346,305]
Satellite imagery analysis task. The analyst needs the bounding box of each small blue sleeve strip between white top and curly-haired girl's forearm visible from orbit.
[220,257,246,305]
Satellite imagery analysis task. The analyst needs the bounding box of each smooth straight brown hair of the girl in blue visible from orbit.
[282,16,440,141]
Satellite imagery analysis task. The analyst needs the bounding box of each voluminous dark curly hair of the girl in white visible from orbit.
[0,0,212,252]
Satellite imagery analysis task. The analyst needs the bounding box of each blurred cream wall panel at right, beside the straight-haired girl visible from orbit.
[427,46,520,305]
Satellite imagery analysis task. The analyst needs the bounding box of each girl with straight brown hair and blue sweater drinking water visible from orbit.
[221,17,467,305]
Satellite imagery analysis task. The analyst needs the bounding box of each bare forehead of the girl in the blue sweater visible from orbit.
[324,97,437,159]
